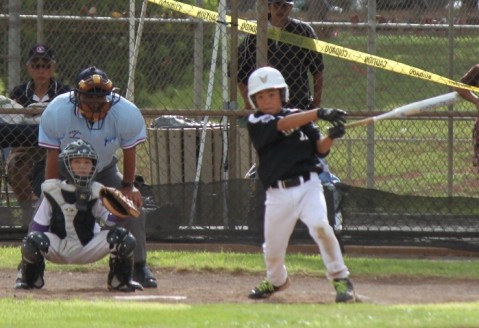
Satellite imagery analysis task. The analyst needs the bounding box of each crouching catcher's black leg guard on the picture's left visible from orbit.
[15,232,50,289]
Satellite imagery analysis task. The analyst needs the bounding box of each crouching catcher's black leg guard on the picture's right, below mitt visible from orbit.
[106,227,143,292]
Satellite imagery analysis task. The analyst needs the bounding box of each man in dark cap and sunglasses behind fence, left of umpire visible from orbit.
[7,44,70,224]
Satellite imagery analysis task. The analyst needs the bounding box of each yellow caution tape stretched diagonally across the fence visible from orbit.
[148,0,479,92]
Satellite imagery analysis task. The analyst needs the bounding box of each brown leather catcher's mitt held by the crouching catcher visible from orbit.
[99,187,140,219]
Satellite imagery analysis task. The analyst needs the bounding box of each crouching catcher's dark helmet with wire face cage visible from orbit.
[58,139,98,188]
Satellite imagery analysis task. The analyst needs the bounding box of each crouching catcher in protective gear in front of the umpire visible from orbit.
[15,140,143,292]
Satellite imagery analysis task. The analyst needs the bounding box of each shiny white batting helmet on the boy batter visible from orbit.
[248,66,289,107]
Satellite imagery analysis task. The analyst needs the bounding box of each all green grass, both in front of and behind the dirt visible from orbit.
[0,246,479,328]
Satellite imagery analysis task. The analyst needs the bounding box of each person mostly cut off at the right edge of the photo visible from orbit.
[455,64,479,169]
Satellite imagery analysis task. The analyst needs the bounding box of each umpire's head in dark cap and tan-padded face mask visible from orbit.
[73,66,120,130]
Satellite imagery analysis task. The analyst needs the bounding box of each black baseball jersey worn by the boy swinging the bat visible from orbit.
[247,108,322,189]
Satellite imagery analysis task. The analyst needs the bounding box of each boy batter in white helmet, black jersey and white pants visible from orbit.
[248,67,356,302]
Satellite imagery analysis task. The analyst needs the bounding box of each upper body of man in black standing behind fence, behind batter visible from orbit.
[238,0,324,109]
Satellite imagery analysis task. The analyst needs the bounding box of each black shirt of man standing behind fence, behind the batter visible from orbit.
[238,18,324,109]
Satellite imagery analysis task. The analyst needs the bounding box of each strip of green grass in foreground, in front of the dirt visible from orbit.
[0,299,479,328]
